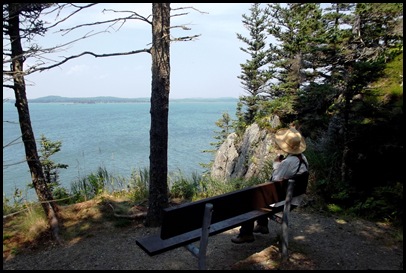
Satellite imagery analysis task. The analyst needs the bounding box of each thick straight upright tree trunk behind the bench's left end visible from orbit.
[145,3,170,227]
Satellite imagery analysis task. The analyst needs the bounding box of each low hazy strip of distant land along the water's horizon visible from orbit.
[6,96,238,104]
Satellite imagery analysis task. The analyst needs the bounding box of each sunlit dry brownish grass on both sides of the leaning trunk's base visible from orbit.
[3,194,143,259]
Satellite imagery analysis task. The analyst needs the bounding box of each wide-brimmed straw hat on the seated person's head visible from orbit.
[275,128,306,154]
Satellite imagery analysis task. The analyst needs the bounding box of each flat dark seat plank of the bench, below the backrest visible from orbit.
[136,209,274,256]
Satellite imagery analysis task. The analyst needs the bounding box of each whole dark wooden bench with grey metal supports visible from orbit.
[136,175,307,269]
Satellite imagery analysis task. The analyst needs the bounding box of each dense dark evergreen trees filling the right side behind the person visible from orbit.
[234,3,404,226]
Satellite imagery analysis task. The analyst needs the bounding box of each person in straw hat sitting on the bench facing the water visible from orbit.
[231,127,308,244]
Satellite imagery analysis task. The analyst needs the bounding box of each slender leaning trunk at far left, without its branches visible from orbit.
[8,3,60,242]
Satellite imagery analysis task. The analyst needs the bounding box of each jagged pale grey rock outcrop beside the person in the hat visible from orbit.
[211,123,275,181]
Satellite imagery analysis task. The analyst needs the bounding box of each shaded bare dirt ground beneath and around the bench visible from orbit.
[3,202,403,270]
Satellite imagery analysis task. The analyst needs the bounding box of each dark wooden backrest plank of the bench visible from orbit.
[161,176,307,239]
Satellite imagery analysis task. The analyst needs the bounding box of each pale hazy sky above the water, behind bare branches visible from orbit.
[3,3,251,99]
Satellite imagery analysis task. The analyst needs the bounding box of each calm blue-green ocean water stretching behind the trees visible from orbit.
[3,99,237,200]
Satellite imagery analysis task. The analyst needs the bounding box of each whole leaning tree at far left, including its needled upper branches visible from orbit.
[3,3,65,241]
